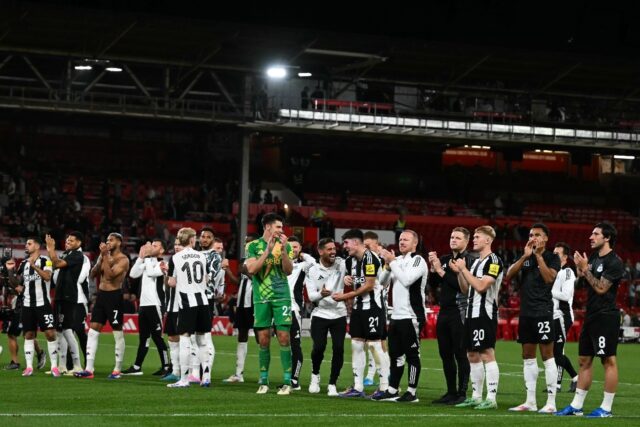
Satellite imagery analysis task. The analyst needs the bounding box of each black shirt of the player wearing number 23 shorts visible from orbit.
[520,249,560,317]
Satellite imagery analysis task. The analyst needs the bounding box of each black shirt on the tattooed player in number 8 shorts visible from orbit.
[587,251,624,318]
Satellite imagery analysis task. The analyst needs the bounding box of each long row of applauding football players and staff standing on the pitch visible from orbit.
[6,214,624,418]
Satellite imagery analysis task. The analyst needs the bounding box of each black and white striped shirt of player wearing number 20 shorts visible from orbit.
[467,252,504,320]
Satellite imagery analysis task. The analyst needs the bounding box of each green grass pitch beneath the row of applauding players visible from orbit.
[0,334,640,427]
